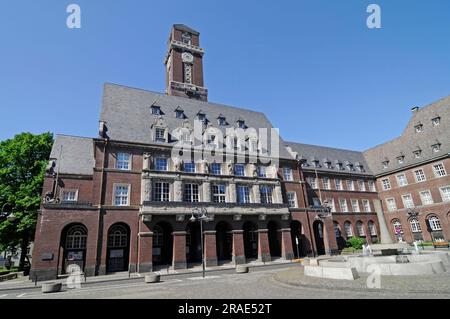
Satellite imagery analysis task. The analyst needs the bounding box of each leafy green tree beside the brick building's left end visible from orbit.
[0,133,53,270]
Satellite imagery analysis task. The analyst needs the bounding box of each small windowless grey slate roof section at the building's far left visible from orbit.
[50,135,95,175]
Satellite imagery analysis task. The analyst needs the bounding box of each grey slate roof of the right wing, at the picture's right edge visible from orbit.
[364,96,450,175]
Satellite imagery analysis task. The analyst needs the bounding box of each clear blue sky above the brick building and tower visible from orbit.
[0,0,450,150]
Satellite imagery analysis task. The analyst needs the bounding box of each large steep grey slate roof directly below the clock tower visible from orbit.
[100,83,291,158]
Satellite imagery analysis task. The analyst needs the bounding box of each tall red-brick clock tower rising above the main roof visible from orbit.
[164,24,208,101]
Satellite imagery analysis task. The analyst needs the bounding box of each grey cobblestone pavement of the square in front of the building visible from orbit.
[0,266,450,299]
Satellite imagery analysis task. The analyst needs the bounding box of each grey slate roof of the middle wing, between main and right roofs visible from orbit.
[286,142,373,176]
